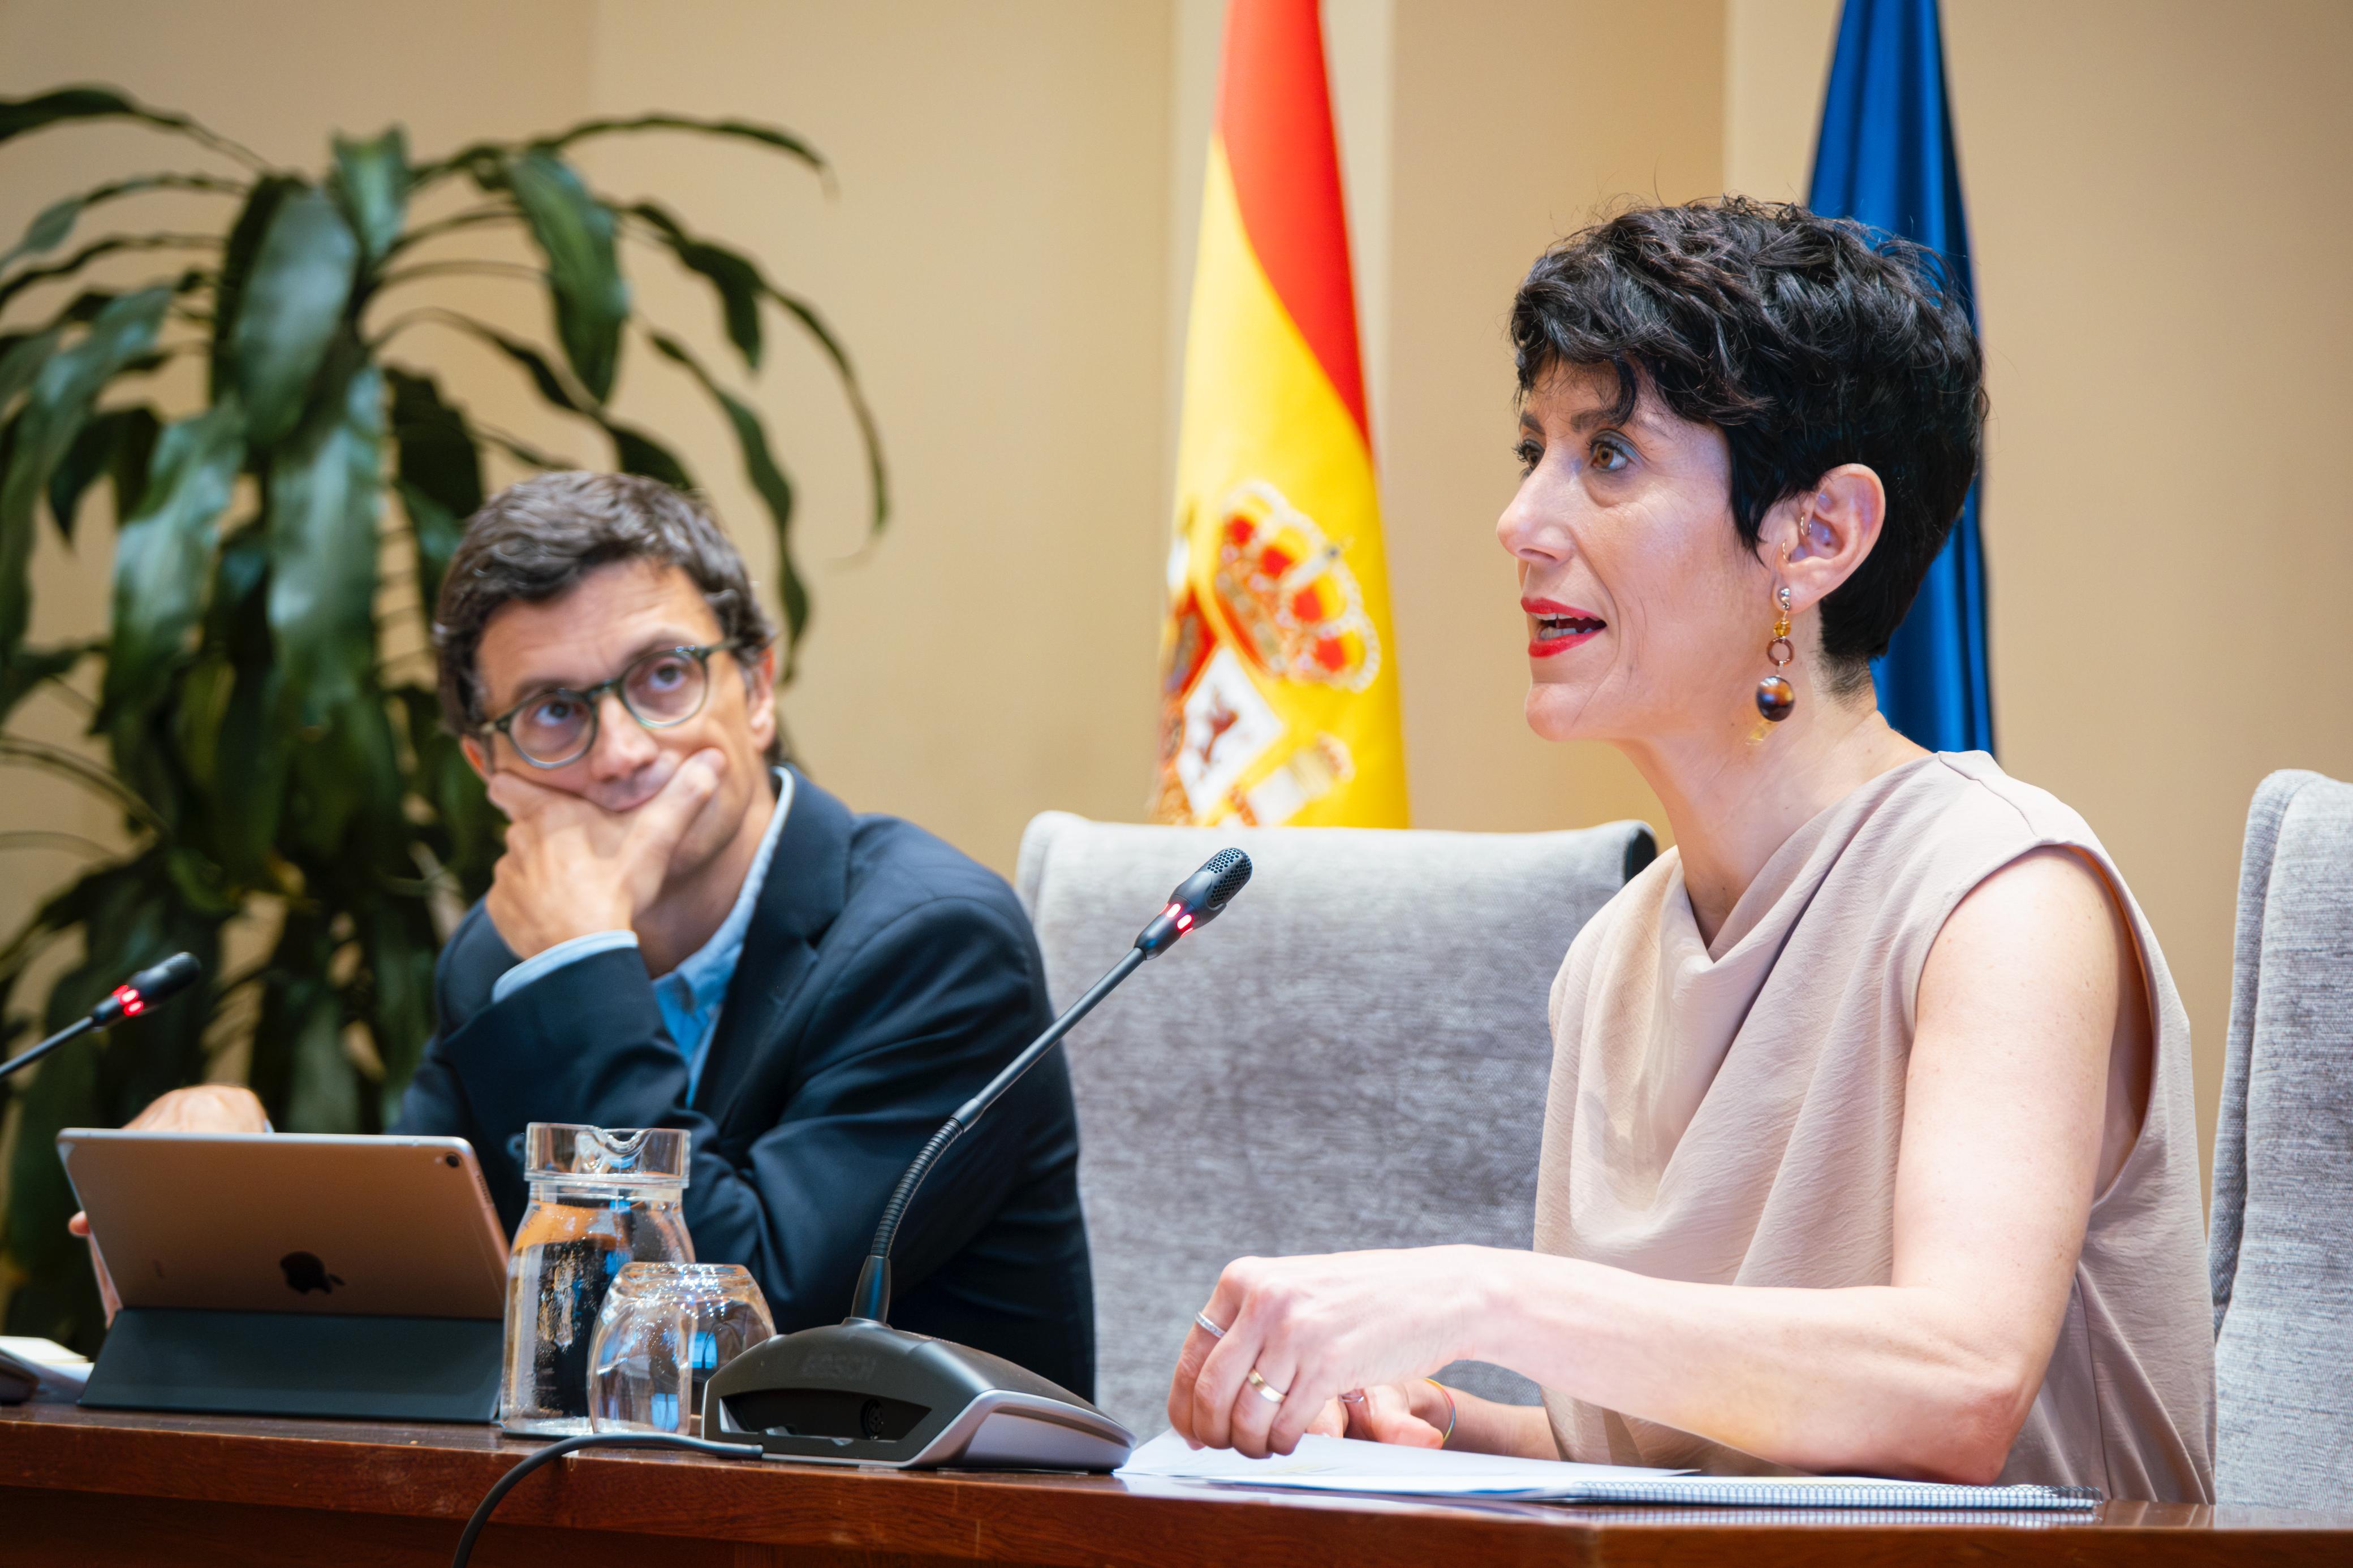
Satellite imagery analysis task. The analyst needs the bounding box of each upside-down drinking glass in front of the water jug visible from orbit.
[588,1263,777,1436]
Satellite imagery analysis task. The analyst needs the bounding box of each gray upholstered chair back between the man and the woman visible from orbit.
[1016,811,1657,1434]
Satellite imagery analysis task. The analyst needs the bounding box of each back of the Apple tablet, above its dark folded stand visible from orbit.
[57,1126,506,1319]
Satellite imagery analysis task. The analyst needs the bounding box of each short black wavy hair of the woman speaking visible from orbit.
[1511,195,1986,689]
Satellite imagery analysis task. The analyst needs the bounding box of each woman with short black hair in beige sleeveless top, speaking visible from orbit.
[1170,197,2214,1502]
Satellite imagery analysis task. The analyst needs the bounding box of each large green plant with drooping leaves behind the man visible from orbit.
[0,87,887,1347]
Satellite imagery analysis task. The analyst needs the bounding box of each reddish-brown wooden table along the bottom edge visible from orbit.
[0,1406,2353,1568]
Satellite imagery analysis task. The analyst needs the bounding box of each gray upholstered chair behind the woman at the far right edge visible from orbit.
[2209,774,2353,1507]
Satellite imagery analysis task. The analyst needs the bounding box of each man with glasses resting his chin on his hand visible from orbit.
[101,473,1094,1394]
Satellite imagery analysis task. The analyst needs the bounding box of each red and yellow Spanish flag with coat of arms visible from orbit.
[1153,0,1407,827]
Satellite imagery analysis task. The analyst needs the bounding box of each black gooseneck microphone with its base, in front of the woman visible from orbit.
[704,849,1249,1469]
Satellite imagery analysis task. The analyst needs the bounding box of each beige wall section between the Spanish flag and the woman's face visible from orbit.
[1377,0,1722,832]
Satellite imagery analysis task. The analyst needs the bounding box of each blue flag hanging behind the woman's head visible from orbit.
[1807,0,1993,752]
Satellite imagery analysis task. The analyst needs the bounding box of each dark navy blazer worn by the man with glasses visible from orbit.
[393,776,1094,1397]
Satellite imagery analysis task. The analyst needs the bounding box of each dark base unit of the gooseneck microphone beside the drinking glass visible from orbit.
[701,1319,1136,1469]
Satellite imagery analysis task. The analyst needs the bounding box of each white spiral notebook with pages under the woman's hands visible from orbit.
[1115,1432,2101,1511]
